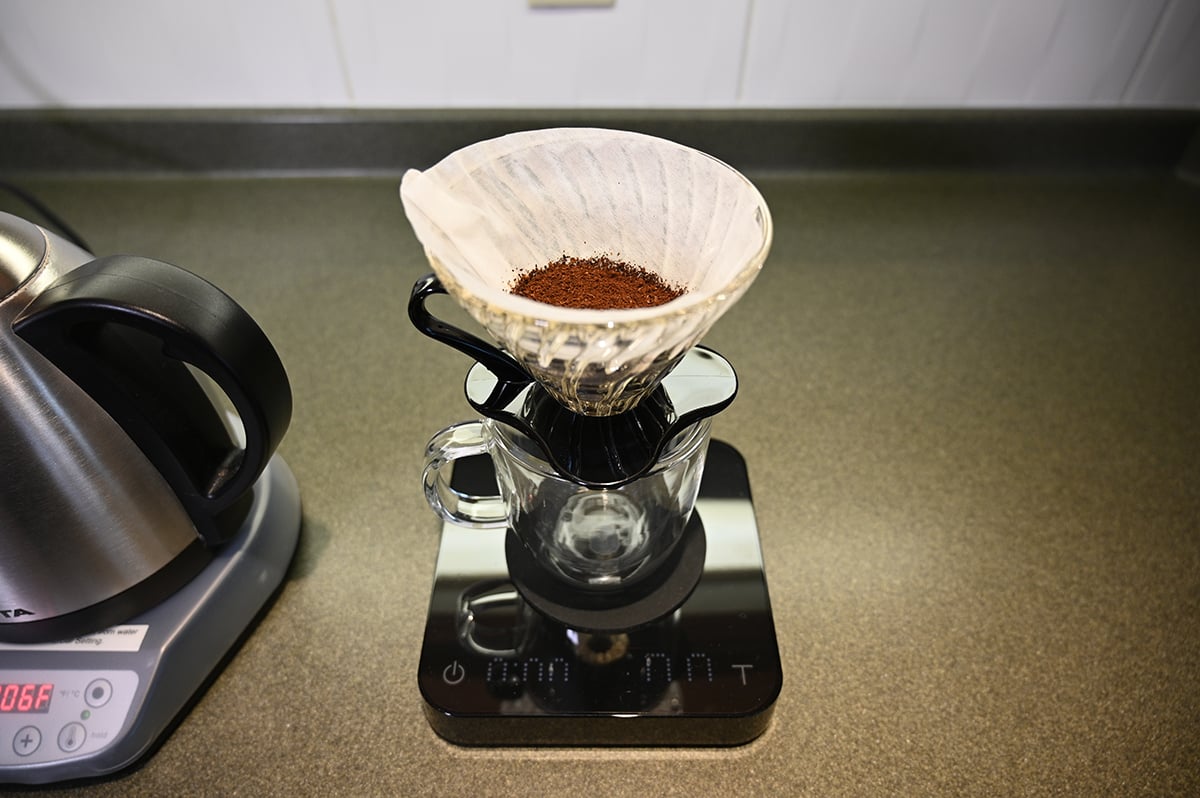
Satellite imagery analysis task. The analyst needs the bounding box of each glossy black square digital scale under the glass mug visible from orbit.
[418,440,782,745]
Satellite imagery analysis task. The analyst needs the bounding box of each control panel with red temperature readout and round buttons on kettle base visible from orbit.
[0,670,138,767]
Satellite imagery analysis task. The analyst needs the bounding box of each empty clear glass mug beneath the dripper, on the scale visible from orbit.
[422,419,712,590]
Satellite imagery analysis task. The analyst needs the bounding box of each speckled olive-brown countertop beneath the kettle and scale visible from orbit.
[0,113,1200,796]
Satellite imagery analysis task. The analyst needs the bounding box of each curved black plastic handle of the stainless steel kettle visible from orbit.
[13,254,292,545]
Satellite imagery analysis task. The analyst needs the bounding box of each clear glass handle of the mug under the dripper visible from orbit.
[421,421,509,529]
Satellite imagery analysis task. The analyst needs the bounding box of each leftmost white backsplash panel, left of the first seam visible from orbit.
[0,0,346,107]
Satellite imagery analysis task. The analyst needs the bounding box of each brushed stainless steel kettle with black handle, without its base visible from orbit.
[0,212,292,643]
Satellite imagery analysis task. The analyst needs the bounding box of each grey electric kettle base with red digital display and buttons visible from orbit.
[0,455,300,784]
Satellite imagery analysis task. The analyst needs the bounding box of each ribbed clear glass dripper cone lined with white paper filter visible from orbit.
[400,128,772,415]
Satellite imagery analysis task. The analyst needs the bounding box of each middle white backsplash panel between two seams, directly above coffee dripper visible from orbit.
[334,0,750,107]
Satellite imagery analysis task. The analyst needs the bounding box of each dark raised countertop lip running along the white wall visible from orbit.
[0,109,1200,176]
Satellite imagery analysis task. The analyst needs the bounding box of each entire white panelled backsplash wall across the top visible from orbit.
[0,0,1200,108]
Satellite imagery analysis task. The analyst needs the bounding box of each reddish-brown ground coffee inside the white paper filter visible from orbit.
[510,254,684,311]
